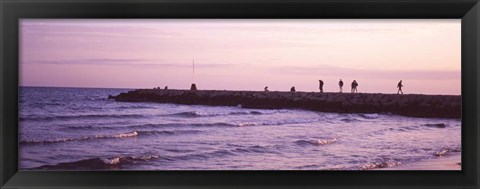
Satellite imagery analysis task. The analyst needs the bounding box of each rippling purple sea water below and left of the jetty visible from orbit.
[19,87,461,170]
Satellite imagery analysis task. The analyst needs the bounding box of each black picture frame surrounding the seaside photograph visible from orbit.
[0,0,480,189]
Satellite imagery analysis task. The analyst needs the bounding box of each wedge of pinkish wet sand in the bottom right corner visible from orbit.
[377,153,462,171]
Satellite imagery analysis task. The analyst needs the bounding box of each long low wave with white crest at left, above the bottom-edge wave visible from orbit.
[19,130,201,144]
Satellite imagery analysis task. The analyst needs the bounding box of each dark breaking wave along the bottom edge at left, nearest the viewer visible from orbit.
[32,155,159,170]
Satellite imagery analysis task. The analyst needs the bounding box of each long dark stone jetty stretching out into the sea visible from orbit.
[108,89,462,119]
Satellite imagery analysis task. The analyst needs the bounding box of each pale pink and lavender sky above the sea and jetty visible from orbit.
[19,19,461,95]
